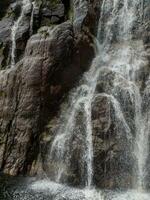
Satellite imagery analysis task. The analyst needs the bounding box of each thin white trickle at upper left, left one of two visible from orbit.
[11,0,31,67]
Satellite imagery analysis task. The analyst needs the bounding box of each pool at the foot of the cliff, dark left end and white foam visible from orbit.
[0,176,150,200]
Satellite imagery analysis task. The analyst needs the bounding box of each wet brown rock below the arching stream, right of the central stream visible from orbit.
[92,94,133,188]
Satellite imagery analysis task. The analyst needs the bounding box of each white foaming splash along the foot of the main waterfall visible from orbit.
[30,180,150,200]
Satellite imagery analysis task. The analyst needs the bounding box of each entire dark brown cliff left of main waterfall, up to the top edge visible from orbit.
[0,0,101,175]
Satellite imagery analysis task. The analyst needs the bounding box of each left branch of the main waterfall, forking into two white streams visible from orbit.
[50,40,99,188]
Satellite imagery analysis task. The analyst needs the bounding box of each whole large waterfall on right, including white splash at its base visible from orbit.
[22,0,150,200]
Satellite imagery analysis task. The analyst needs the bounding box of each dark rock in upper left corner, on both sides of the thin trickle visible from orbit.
[0,1,31,69]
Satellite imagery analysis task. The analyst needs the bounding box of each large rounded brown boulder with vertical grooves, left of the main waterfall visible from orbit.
[0,22,73,174]
